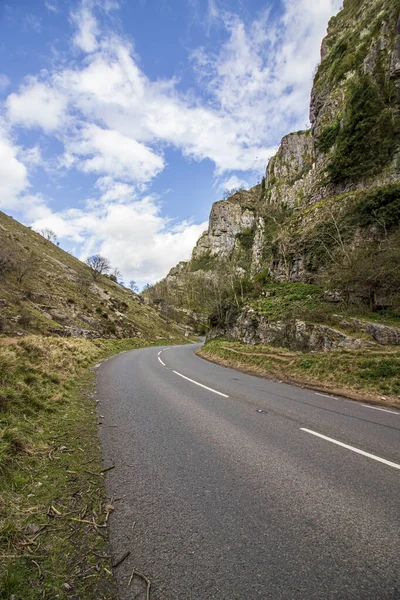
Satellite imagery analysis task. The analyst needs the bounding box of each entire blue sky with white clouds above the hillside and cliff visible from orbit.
[0,0,341,286]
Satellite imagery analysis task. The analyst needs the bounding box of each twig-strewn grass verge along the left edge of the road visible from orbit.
[0,336,182,600]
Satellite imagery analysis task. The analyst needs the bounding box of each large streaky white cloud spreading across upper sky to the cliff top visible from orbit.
[3,0,340,181]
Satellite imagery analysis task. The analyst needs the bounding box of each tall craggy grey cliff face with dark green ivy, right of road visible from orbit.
[182,0,400,281]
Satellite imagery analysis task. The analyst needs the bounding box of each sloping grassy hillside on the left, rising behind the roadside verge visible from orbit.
[0,212,184,339]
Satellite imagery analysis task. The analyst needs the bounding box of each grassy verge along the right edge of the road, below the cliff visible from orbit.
[197,339,400,408]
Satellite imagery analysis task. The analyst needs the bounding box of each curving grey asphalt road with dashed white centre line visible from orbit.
[97,345,400,600]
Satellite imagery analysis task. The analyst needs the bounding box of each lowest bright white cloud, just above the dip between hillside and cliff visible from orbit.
[28,193,207,283]
